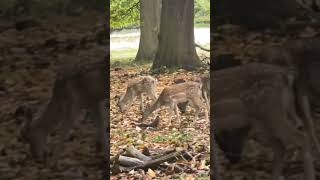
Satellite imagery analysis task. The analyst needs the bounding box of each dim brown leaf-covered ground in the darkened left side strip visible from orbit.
[0,13,106,180]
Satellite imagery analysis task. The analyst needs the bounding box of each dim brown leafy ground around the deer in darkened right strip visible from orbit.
[211,25,320,180]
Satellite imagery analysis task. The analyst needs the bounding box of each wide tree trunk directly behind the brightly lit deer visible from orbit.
[152,0,201,69]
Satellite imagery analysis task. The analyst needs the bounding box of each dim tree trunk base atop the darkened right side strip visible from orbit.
[213,0,299,28]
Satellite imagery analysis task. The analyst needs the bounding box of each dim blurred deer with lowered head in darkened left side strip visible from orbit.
[21,62,109,163]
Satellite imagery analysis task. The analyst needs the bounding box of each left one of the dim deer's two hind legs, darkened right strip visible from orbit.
[271,139,285,180]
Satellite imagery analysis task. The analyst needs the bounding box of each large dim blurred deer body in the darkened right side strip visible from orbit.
[211,63,320,180]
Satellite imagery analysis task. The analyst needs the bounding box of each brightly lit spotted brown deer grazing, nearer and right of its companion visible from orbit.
[141,82,208,127]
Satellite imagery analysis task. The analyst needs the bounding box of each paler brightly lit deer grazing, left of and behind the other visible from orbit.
[117,76,158,112]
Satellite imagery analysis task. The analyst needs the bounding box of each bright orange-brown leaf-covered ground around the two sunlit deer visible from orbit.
[110,65,210,179]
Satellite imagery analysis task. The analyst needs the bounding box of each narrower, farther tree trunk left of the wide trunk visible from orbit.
[135,0,161,61]
